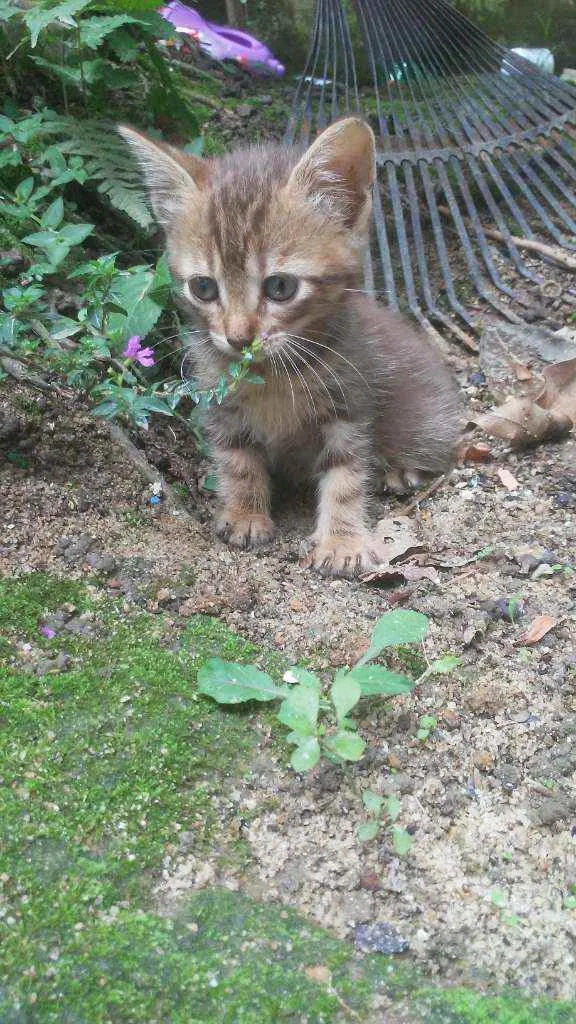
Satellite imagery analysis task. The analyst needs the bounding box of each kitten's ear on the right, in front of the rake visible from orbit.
[288,118,376,227]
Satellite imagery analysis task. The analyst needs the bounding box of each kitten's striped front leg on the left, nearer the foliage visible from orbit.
[213,445,274,548]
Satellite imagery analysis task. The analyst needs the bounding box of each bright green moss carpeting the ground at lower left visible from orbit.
[0,573,576,1024]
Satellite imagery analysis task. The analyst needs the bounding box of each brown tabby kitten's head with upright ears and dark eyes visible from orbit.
[120,118,375,358]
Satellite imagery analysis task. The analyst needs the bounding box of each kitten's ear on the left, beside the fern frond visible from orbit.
[118,125,208,227]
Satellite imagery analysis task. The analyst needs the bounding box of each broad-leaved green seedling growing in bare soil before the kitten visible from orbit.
[198,609,458,772]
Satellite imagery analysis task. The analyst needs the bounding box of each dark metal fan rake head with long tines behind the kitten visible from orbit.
[287,0,576,349]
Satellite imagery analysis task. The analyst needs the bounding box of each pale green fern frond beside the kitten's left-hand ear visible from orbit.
[43,117,153,228]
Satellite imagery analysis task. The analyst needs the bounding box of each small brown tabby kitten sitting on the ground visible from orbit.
[120,118,459,575]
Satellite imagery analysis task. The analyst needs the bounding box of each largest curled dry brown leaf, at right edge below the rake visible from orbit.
[476,358,576,447]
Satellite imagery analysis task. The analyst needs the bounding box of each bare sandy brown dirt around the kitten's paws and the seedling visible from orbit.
[0,315,576,1011]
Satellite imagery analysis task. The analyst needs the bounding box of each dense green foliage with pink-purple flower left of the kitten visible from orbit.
[0,0,258,442]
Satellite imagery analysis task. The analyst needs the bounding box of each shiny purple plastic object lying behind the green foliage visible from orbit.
[160,0,285,77]
